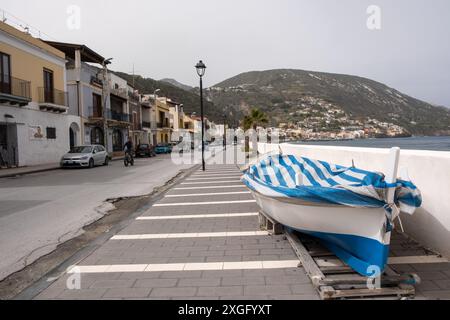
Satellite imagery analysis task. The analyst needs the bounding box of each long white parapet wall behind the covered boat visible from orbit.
[258,143,450,257]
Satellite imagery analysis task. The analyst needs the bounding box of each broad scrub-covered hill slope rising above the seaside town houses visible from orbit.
[208,69,450,135]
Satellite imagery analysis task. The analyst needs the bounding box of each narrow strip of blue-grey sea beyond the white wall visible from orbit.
[294,136,450,151]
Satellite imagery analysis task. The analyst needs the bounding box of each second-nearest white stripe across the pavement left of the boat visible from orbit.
[111,231,269,240]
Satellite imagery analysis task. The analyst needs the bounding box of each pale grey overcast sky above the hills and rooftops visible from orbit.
[0,0,450,107]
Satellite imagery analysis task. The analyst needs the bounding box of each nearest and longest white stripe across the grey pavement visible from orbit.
[67,260,299,274]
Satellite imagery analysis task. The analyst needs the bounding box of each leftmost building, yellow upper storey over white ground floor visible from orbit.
[0,22,78,166]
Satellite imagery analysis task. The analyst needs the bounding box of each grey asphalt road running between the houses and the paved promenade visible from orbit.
[0,155,192,280]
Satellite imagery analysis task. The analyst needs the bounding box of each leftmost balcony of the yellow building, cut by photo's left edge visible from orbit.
[0,74,31,107]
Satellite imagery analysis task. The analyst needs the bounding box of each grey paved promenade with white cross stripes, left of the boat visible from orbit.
[36,165,318,300]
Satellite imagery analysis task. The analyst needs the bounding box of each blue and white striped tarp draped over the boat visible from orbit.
[242,155,422,214]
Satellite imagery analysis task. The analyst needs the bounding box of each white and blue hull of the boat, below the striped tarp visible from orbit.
[252,191,391,275]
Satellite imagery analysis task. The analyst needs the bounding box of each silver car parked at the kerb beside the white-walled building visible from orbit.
[61,145,109,168]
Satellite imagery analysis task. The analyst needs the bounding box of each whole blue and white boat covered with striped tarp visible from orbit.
[242,148,422,276]
